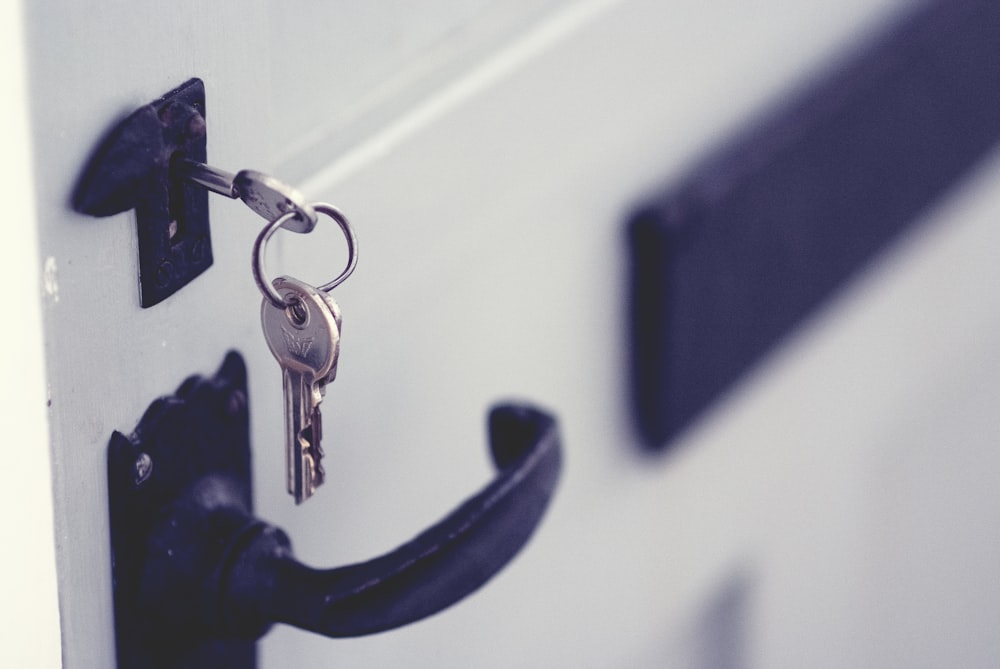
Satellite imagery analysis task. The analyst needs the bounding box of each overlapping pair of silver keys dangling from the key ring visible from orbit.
[261,276,340,504]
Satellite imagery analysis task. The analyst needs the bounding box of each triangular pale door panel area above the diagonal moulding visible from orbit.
[267,0,562,181]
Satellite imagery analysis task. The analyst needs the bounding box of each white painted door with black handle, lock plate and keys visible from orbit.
[4,0,1000,668]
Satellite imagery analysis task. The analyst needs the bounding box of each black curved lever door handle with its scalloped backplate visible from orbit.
[108,353,562,669]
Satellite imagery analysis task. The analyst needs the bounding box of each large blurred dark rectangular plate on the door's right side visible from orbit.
[628,0,1000,448]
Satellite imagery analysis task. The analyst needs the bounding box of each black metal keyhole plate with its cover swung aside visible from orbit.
[73,79,212,307]
